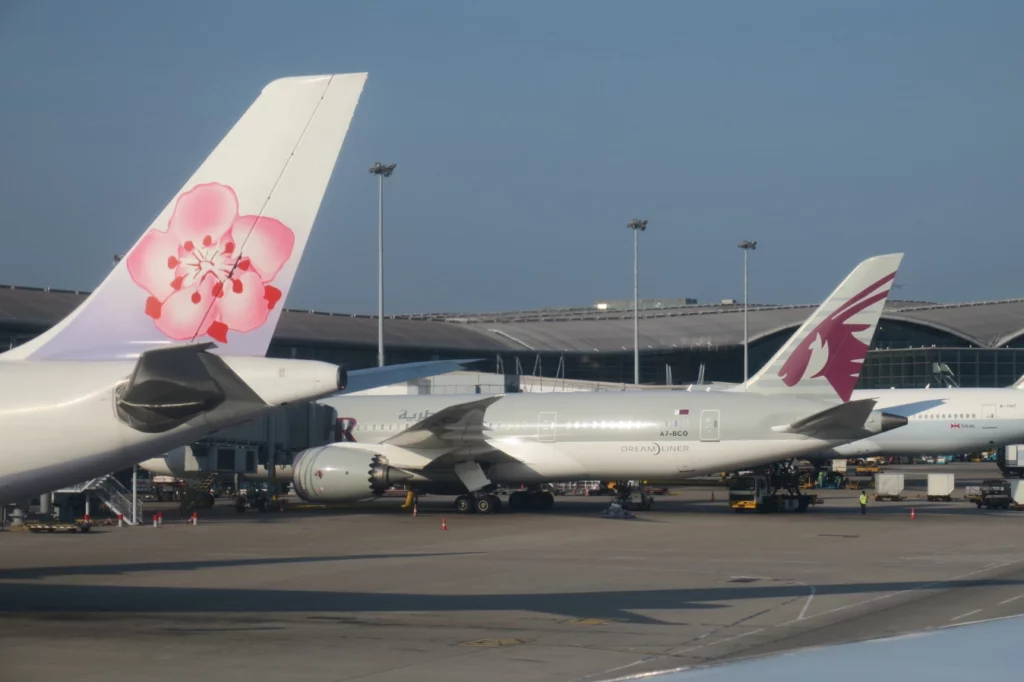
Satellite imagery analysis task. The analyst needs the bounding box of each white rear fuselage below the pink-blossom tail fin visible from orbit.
[0,357,338,504]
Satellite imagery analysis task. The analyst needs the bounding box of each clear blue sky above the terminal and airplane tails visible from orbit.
[0,0,1024,312]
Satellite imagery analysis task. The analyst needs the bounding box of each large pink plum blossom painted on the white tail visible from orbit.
[126,182,295,343]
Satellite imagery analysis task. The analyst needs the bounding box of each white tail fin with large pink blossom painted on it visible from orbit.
[2,74,367,359]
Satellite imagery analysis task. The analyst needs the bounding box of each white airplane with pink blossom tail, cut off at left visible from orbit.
[0,74,462,504]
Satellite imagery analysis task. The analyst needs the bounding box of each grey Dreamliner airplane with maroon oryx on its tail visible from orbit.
[142,254,907,513]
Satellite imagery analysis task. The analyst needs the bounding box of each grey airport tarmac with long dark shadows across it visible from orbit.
[0,464,1024,682]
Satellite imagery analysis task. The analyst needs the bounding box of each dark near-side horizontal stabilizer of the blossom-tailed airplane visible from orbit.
[117,343,266,433]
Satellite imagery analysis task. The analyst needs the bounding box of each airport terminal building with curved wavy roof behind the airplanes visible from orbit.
[6,286,1024,388]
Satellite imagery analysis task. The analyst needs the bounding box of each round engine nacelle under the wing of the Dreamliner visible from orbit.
[292,445,413,503]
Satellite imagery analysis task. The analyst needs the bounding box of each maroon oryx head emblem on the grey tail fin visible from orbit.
[778,272,896,402]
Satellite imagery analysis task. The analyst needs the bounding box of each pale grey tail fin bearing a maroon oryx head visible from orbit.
[736,253,903,402]
